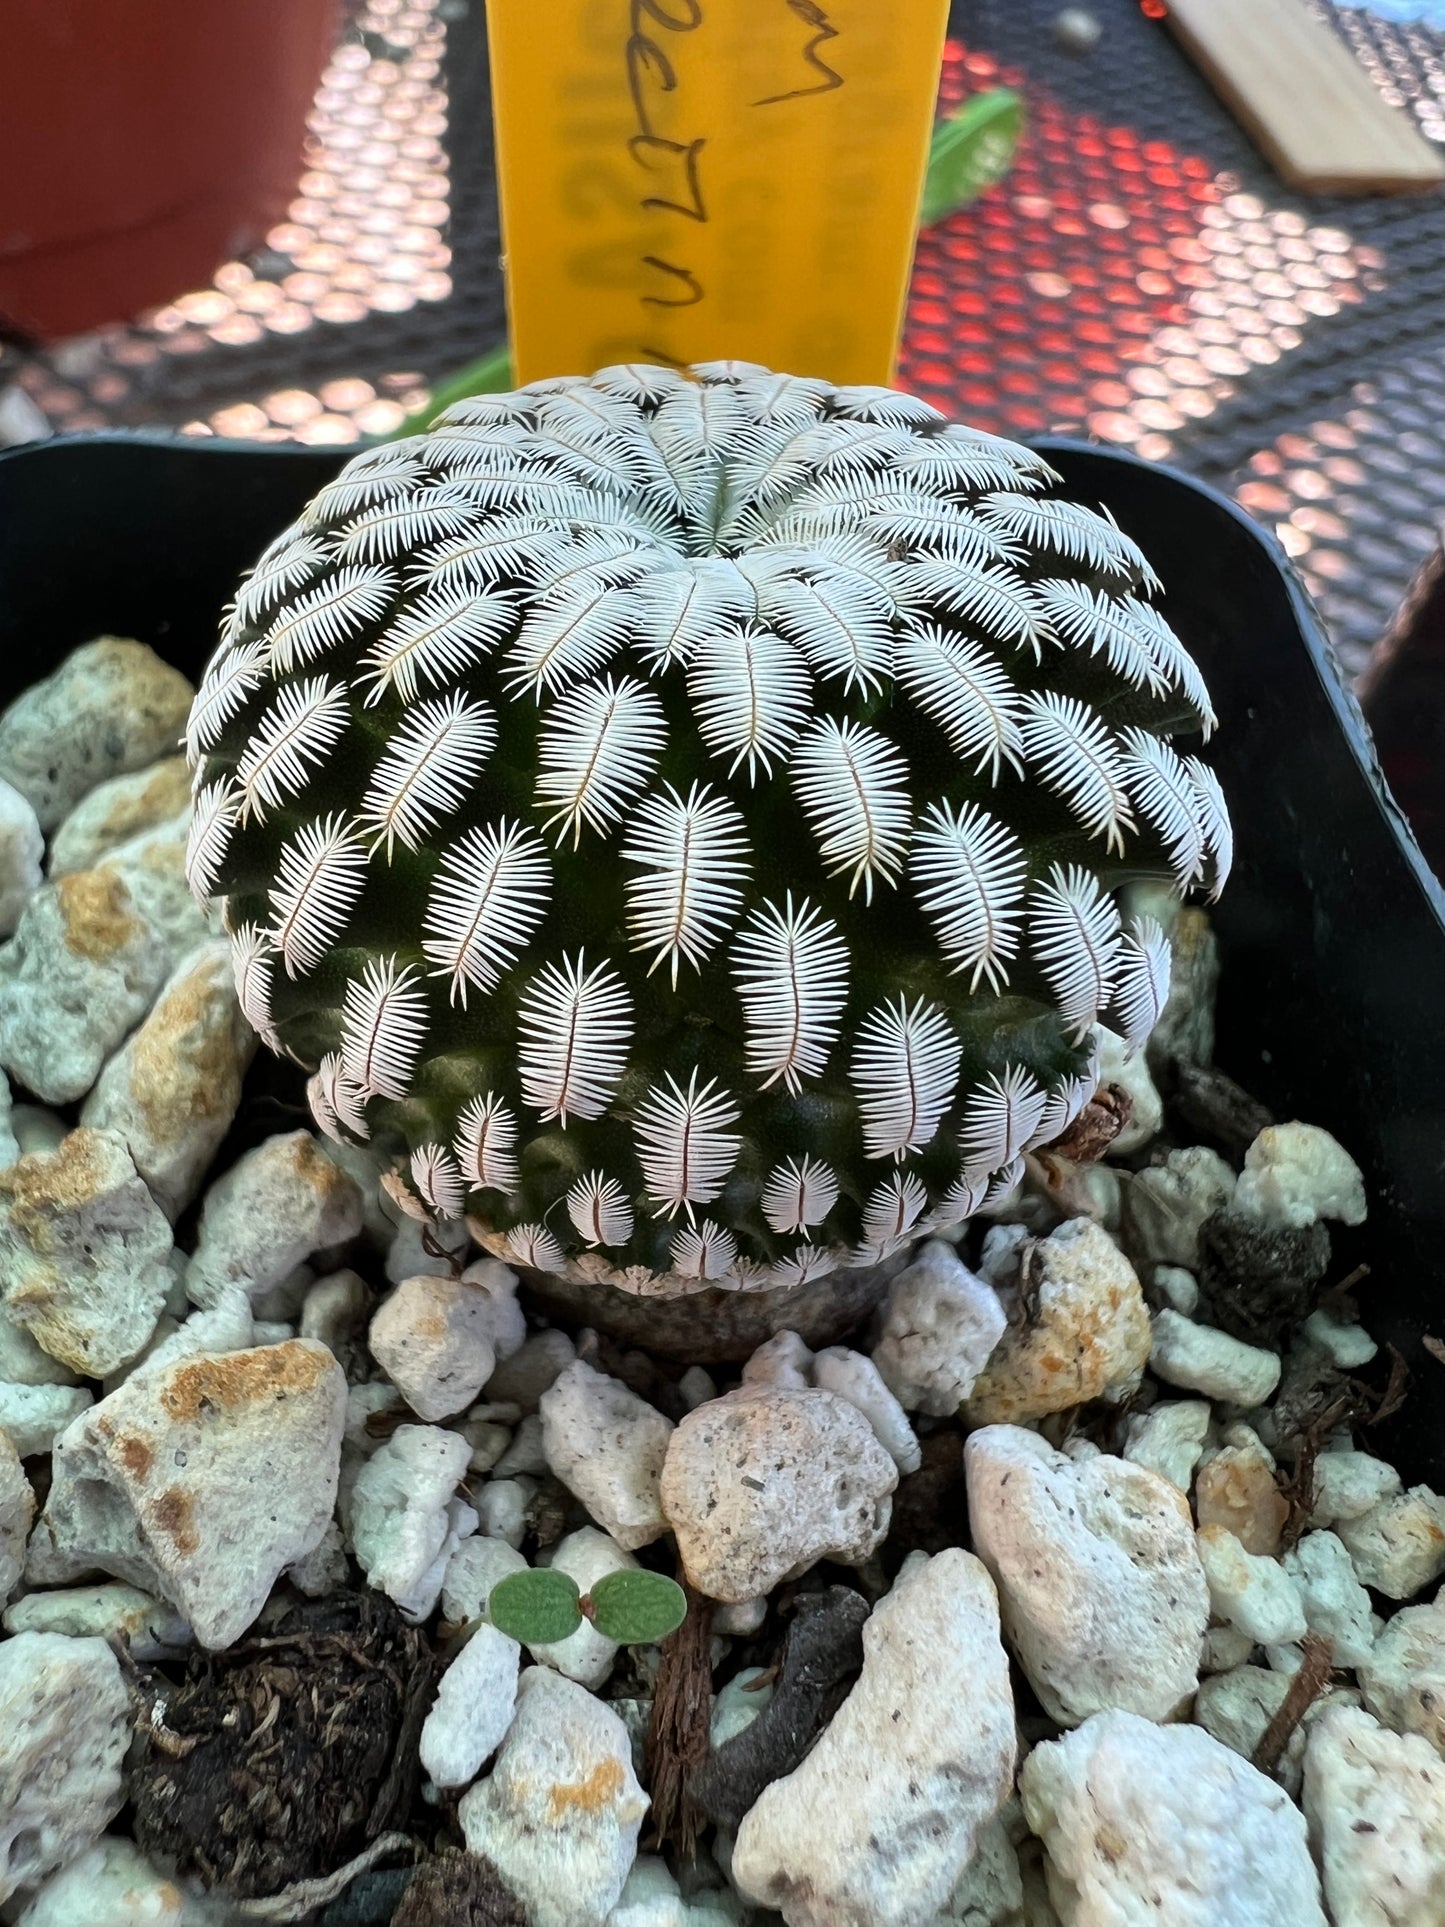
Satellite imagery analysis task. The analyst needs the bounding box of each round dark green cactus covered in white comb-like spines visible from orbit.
[189,362,1229,1293]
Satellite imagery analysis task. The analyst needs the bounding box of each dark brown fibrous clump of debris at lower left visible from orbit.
[131,1592,434,1896]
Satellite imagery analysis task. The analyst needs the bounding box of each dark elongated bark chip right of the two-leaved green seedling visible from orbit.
[692,1586,869,1827]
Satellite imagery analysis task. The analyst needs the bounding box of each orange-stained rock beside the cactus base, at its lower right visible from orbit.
[963,1218,1150,1426]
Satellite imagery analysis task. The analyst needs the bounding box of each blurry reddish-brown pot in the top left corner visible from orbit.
[0,0,339,339]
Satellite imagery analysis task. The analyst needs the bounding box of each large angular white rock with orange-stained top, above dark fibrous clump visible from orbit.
[29,1339,347,1650]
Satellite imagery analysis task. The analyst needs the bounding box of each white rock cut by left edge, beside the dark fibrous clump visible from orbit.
[0,1632,131,1900]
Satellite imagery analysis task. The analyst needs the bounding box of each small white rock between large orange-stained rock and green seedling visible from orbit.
[351,1426,470,1621]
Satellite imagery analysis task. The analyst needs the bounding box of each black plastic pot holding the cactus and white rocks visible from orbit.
[0,436,1445,1484]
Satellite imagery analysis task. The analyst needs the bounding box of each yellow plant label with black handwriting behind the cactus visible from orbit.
[487,0,948,382]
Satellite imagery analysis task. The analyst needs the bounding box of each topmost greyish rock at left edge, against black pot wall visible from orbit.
[0,636,195,831]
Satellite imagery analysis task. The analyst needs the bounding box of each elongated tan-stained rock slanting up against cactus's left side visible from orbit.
[81,940,256,1222]
